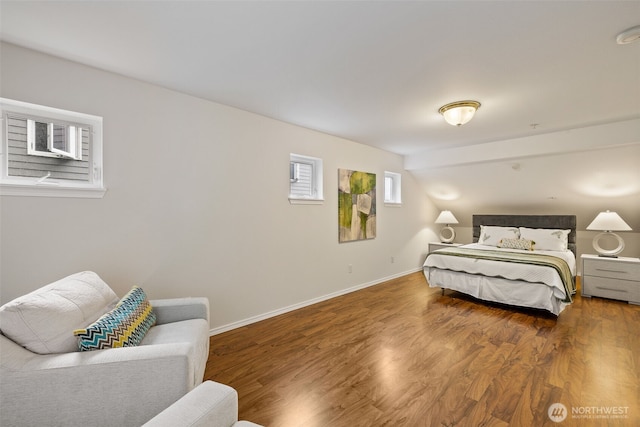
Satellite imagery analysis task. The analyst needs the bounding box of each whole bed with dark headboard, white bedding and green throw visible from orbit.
[424,215,576,316]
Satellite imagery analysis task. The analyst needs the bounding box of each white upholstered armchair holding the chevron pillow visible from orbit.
[0,272,211,427]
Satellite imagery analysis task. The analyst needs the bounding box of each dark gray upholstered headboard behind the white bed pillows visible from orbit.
[473,215,576,254]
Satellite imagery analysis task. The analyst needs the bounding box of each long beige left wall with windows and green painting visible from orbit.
[0,44,437,330]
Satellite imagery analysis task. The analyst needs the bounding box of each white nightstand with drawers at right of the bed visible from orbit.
[581,255,640,304]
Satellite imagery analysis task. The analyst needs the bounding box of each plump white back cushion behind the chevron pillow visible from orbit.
[0,271,118,354]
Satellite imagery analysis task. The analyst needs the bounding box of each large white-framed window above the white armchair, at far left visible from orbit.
[0,98,106,198]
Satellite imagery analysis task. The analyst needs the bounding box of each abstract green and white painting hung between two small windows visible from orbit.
[338,169,376,243]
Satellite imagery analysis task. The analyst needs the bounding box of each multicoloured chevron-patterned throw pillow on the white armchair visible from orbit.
[73,286,156,351]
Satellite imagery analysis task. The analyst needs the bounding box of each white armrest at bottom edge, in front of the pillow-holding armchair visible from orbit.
[144,381,238,427]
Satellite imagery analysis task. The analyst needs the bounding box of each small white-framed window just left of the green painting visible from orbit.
[289,154,323,203]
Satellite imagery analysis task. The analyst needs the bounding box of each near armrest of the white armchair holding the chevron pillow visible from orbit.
[0,335,200,426]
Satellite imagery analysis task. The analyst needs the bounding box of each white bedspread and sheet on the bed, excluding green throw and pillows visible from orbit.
[424,243,576,315]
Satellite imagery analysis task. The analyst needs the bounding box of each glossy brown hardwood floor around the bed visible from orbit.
[205,272,640,427]
